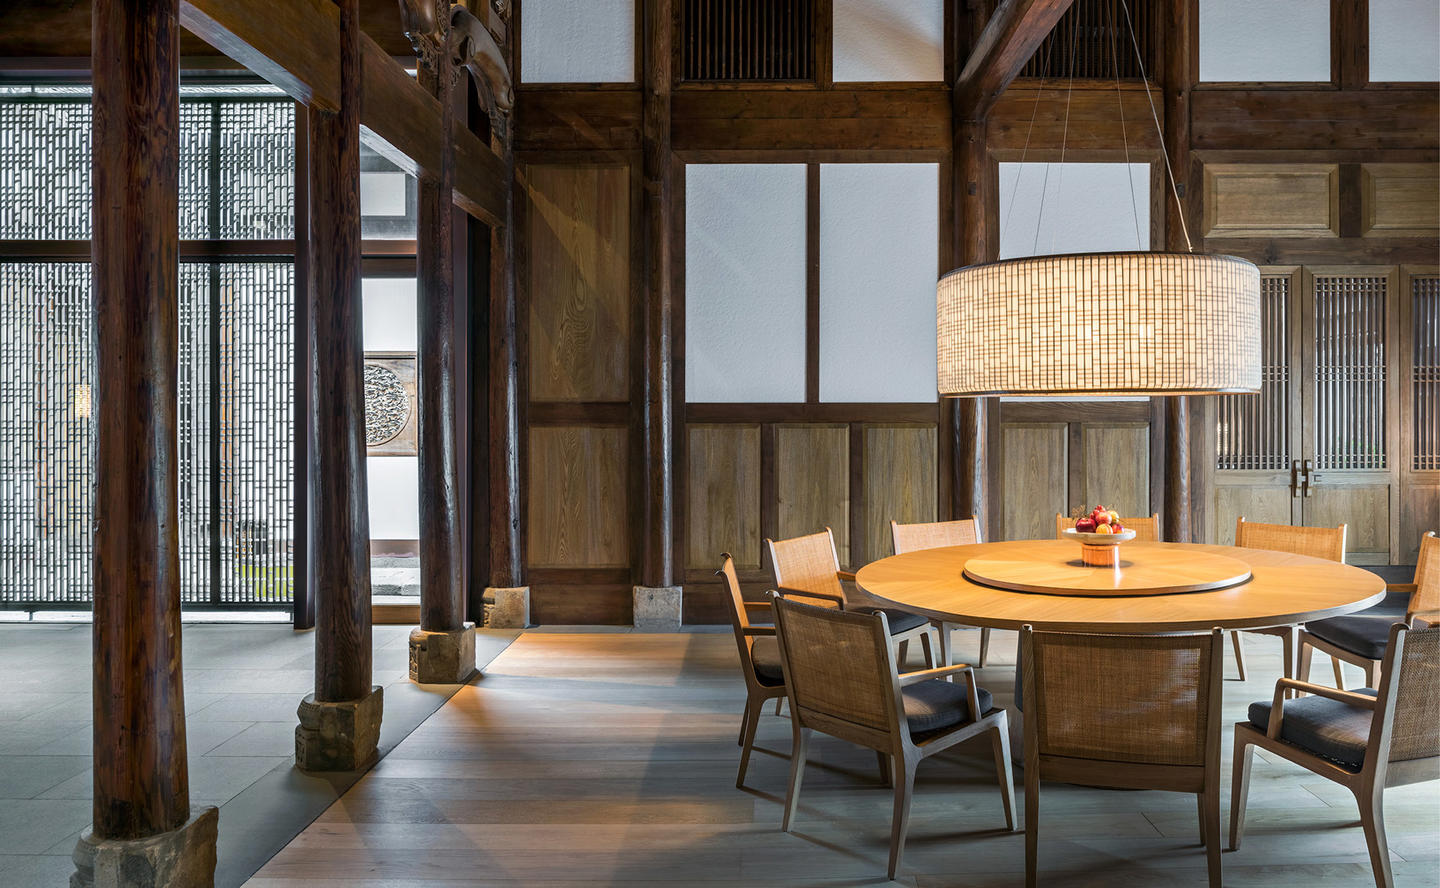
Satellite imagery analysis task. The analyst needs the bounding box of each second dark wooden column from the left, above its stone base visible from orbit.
[310,0,372,702]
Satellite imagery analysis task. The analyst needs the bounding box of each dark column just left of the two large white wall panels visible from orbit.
[639,0,675,589]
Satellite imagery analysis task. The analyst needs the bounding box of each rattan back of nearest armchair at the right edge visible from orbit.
[1371,625,1440,761]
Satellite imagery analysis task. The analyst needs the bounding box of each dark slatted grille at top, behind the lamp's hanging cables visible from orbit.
[1020,0,1159,81]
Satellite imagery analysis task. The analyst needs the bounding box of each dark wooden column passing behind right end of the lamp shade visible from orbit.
[1164,0,1208,543]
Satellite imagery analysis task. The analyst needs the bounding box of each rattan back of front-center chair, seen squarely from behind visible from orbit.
[1021,629,1223,767]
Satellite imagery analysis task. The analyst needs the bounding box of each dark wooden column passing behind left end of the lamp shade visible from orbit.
[942,109,995,540]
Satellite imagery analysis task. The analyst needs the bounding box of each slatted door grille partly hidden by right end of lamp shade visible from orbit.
[1215,275,1290,471]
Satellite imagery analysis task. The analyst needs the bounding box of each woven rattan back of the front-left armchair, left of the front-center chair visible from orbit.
[775,597,897,740]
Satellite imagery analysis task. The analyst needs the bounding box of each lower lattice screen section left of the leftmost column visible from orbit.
[0,262,95,609]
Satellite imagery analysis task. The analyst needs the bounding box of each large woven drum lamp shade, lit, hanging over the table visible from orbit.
[936,252,1260,397]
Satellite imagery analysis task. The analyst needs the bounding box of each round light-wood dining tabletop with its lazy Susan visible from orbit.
[855,540,1385,635]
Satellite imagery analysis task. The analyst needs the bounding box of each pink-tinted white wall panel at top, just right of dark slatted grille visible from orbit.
[832,0,945,82]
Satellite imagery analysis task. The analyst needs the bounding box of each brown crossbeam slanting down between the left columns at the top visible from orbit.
[180,0,508,225]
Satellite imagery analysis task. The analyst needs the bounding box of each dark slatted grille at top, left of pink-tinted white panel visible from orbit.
[681,0,815,81]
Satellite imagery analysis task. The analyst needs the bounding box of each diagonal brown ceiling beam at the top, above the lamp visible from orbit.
[955,0,1073,121]
